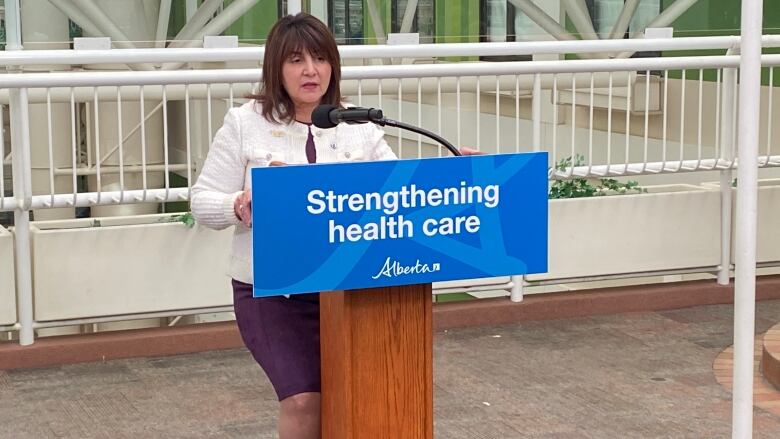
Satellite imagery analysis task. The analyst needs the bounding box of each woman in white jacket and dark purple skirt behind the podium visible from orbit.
[192,13,396,439]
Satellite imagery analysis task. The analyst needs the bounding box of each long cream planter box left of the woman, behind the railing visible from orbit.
[30,215,232,321]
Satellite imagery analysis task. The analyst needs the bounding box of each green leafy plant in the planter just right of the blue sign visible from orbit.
[548,154,647,199]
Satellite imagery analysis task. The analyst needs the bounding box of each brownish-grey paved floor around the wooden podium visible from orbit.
[0,300,780,439]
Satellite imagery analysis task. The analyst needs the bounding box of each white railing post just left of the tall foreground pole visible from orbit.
[718,55,738,285]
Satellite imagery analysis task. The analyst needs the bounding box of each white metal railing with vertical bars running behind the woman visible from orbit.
[0,37,780,346]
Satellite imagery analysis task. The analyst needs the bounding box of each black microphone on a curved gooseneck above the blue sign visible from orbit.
[311,104,462,156]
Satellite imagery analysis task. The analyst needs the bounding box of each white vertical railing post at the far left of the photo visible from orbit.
[5,0,35,345]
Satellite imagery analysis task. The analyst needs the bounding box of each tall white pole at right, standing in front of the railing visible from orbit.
[731,0,763,439]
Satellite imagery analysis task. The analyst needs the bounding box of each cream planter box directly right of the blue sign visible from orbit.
[527,185,720,281]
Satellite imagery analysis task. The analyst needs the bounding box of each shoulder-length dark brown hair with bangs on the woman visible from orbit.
[249,12,341,123]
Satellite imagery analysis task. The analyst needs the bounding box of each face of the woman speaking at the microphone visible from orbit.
[282,52,331,108]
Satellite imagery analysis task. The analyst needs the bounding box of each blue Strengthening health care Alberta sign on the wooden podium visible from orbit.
[252,152,547,297]
